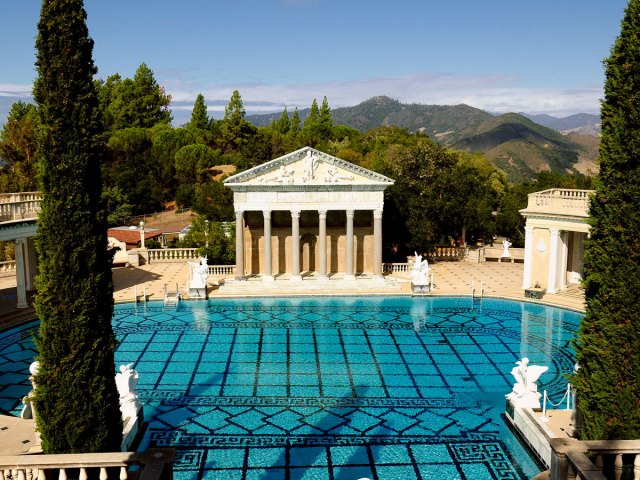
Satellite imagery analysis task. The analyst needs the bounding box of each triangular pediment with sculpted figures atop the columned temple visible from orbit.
[224,147,394,189]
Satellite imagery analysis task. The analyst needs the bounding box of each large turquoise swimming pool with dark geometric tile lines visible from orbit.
[0,297,580,480]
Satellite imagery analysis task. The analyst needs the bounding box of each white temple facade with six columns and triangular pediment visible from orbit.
[224,147,394,281]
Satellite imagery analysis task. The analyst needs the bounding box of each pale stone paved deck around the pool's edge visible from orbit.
[0,262,584,455]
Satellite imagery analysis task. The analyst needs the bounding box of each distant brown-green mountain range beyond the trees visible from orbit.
[247,96,600,182]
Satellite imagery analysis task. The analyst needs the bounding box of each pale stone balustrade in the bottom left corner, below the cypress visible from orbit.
[0,448,175,480]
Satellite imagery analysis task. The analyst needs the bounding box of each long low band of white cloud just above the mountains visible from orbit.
[165,73,602,116]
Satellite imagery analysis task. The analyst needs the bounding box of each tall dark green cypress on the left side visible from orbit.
[33,0,122,453]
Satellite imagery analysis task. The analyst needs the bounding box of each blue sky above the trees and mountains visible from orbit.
[0,0,627,123]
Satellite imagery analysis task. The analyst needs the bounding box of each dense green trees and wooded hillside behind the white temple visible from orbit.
[0,77,590,259]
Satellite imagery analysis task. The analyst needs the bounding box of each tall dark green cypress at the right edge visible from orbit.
[574,0,640,439]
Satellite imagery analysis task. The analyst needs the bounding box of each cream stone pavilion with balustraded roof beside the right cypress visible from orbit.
[520,188,594,293]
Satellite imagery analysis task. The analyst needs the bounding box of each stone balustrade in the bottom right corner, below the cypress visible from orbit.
[550,438,640,480]
